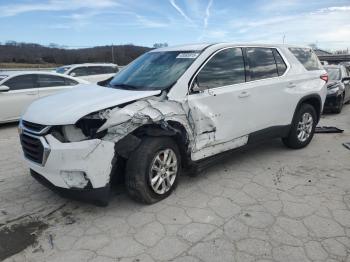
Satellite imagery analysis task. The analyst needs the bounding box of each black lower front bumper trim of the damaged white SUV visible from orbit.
[30,169,110,206]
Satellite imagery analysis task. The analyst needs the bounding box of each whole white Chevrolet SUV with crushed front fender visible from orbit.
[19,43,327,204]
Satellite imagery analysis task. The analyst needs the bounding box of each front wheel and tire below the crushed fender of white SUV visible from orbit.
[125,137,181,204]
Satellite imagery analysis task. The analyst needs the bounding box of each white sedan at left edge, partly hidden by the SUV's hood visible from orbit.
[0,71,89,123]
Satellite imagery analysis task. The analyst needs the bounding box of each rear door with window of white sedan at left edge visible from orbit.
[38,74,78,97]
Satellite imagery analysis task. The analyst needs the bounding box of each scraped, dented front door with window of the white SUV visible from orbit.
[188,48,253,160]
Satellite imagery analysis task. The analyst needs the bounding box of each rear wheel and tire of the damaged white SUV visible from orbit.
[282,104,317,149]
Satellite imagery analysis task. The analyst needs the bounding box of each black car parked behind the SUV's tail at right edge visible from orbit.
[324,65,350,113]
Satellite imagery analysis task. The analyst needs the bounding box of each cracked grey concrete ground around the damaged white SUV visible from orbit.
[0,106,350,262]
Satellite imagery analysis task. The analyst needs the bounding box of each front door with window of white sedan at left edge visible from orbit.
[0,74,39,122]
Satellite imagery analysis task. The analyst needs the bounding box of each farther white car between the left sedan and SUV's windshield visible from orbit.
[56,63,119,83]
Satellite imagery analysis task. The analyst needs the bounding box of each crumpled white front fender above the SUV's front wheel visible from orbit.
[98,95,216,156]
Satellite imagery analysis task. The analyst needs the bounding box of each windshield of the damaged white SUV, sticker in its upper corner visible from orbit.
[109,51,199,91]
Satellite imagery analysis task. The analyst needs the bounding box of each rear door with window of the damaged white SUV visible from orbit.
[245,47,296,131]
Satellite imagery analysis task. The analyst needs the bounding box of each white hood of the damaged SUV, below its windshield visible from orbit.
[22,85,161,125]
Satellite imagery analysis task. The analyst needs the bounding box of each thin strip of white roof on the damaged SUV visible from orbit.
[151,42,311,52]
